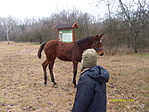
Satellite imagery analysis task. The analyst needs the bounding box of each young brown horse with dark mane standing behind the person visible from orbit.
[38,34,104,86]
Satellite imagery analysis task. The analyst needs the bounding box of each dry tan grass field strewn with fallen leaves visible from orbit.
[0,42,149,112]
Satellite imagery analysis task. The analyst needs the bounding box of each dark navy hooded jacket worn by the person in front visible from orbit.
[72,65,109,112]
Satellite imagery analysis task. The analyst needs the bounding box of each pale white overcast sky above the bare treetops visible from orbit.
[0,0,106,18]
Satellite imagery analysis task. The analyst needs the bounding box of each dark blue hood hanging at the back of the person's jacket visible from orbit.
[84,65,109,83]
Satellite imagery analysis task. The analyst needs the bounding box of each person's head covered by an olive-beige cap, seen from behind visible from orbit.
[80,49,97,71]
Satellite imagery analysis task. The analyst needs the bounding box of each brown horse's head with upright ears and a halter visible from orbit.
[92,34,104,56]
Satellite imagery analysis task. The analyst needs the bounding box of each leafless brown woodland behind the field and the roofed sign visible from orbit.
[0,0,149,54]
